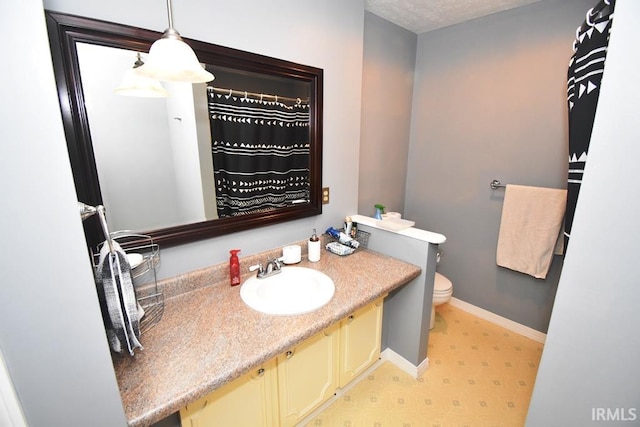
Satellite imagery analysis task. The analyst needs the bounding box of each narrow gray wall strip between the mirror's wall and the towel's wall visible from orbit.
[358,12,418,216]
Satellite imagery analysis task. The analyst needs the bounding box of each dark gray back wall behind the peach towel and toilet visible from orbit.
[405,0,593,332]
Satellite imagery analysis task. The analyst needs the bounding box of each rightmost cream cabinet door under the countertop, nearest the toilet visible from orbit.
[339,298,384,387]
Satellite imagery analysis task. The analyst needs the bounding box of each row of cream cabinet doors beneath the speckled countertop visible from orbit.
[180,297,383,427]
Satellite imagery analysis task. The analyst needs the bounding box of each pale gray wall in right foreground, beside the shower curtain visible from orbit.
[527,0,640,427]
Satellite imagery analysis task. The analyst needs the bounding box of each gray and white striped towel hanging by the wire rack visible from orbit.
[96,242,143,356]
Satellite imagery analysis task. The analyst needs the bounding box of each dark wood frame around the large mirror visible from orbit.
[45,11,323,247]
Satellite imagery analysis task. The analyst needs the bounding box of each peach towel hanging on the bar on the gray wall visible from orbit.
[496,185,567,279]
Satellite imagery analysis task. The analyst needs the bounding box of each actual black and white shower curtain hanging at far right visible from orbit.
[564,0,615,249]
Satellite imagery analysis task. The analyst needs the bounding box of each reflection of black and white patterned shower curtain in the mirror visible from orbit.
[208,88,310,218]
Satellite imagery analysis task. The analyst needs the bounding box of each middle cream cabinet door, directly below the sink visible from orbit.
[277,324,340,427]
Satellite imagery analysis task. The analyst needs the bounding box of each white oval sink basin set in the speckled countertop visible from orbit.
[240,266,336,315]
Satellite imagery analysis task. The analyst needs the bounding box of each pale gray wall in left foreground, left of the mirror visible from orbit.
[0,0,125,427]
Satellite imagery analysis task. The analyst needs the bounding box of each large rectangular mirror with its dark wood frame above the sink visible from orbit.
[46,11,323,247]
